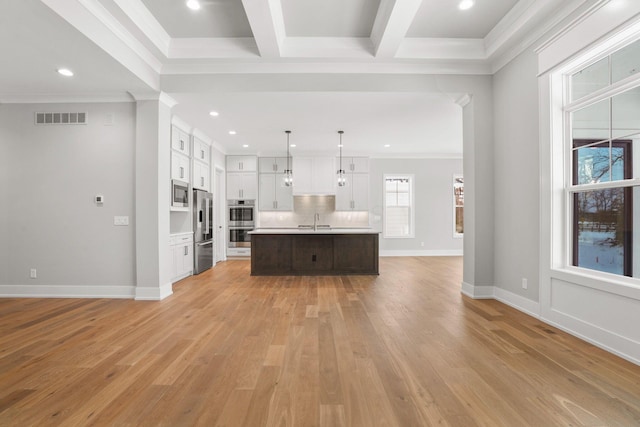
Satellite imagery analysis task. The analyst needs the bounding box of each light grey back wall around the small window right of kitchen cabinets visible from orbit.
[369,159,463,255]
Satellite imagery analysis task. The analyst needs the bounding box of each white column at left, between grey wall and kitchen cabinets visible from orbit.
[134,93,175,300]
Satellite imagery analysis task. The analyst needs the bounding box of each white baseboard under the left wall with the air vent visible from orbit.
[0,285,136,299]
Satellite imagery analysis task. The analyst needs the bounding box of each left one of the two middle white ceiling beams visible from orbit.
[242,0,285,58]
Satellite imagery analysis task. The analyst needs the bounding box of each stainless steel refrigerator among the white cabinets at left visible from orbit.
[193,190,213,274]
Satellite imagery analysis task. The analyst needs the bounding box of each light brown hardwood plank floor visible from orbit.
[0,257,640,427]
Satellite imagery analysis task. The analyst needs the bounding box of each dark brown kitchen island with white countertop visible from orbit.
[250,228,379,276]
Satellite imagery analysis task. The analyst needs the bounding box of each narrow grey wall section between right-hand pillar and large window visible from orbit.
[493,49,540,302]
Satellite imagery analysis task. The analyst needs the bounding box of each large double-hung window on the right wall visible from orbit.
[563,36,640,277]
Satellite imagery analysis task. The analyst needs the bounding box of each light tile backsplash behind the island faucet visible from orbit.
[258,196,369,228]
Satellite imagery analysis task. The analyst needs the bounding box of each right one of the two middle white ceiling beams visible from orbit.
[371,0,422,58]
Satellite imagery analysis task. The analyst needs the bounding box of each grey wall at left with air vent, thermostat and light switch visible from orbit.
[0,103,135,297]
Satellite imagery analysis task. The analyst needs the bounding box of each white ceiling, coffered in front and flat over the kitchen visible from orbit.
[0,0,587,156]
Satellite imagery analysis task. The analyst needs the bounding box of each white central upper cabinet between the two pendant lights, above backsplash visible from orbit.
[293,157,337,195]
